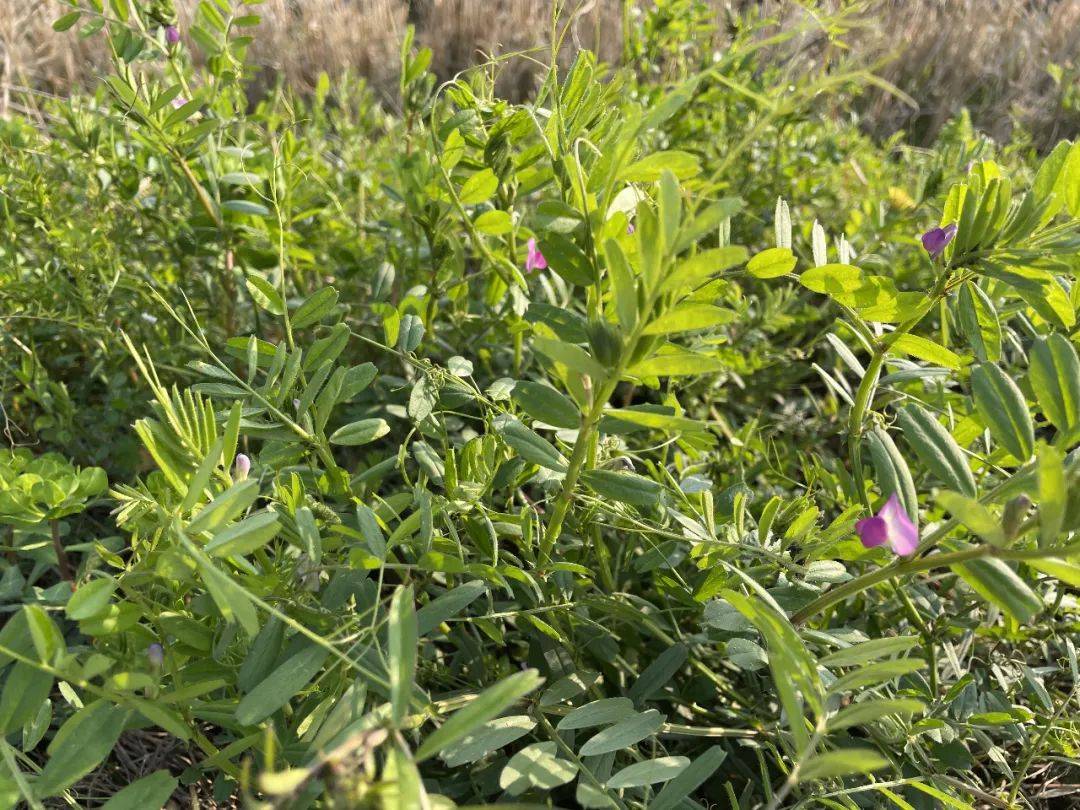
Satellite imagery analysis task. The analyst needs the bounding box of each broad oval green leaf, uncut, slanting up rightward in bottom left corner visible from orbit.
[35,700,131,797]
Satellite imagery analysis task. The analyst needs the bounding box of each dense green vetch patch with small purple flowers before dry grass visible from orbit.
[0,0,1080,810]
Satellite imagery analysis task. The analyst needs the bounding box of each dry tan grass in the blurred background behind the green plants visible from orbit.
[0,0,1080,143]
